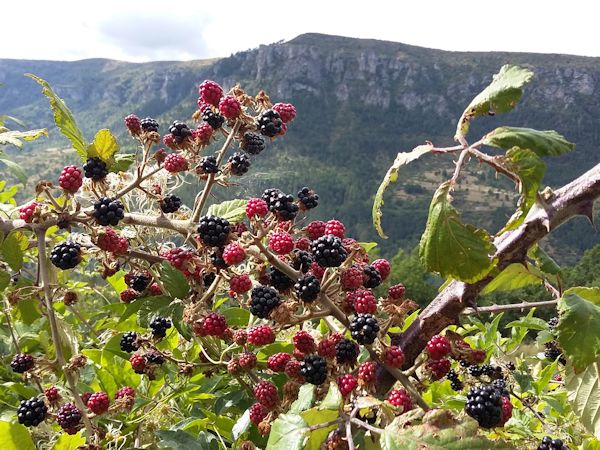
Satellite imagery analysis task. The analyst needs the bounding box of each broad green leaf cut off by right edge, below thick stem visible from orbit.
[557,288,600,372]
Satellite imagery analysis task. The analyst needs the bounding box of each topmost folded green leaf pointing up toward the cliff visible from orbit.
[456,64,533,139]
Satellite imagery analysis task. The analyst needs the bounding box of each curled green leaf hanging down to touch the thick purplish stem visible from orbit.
[502,147,546,231]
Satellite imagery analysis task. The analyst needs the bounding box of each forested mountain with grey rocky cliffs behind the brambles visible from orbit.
[0,34,600,261]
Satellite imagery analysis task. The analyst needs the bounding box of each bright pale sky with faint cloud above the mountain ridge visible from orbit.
[0,0,600,62]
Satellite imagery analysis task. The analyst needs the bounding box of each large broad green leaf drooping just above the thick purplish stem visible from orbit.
[419,181,495,283]
